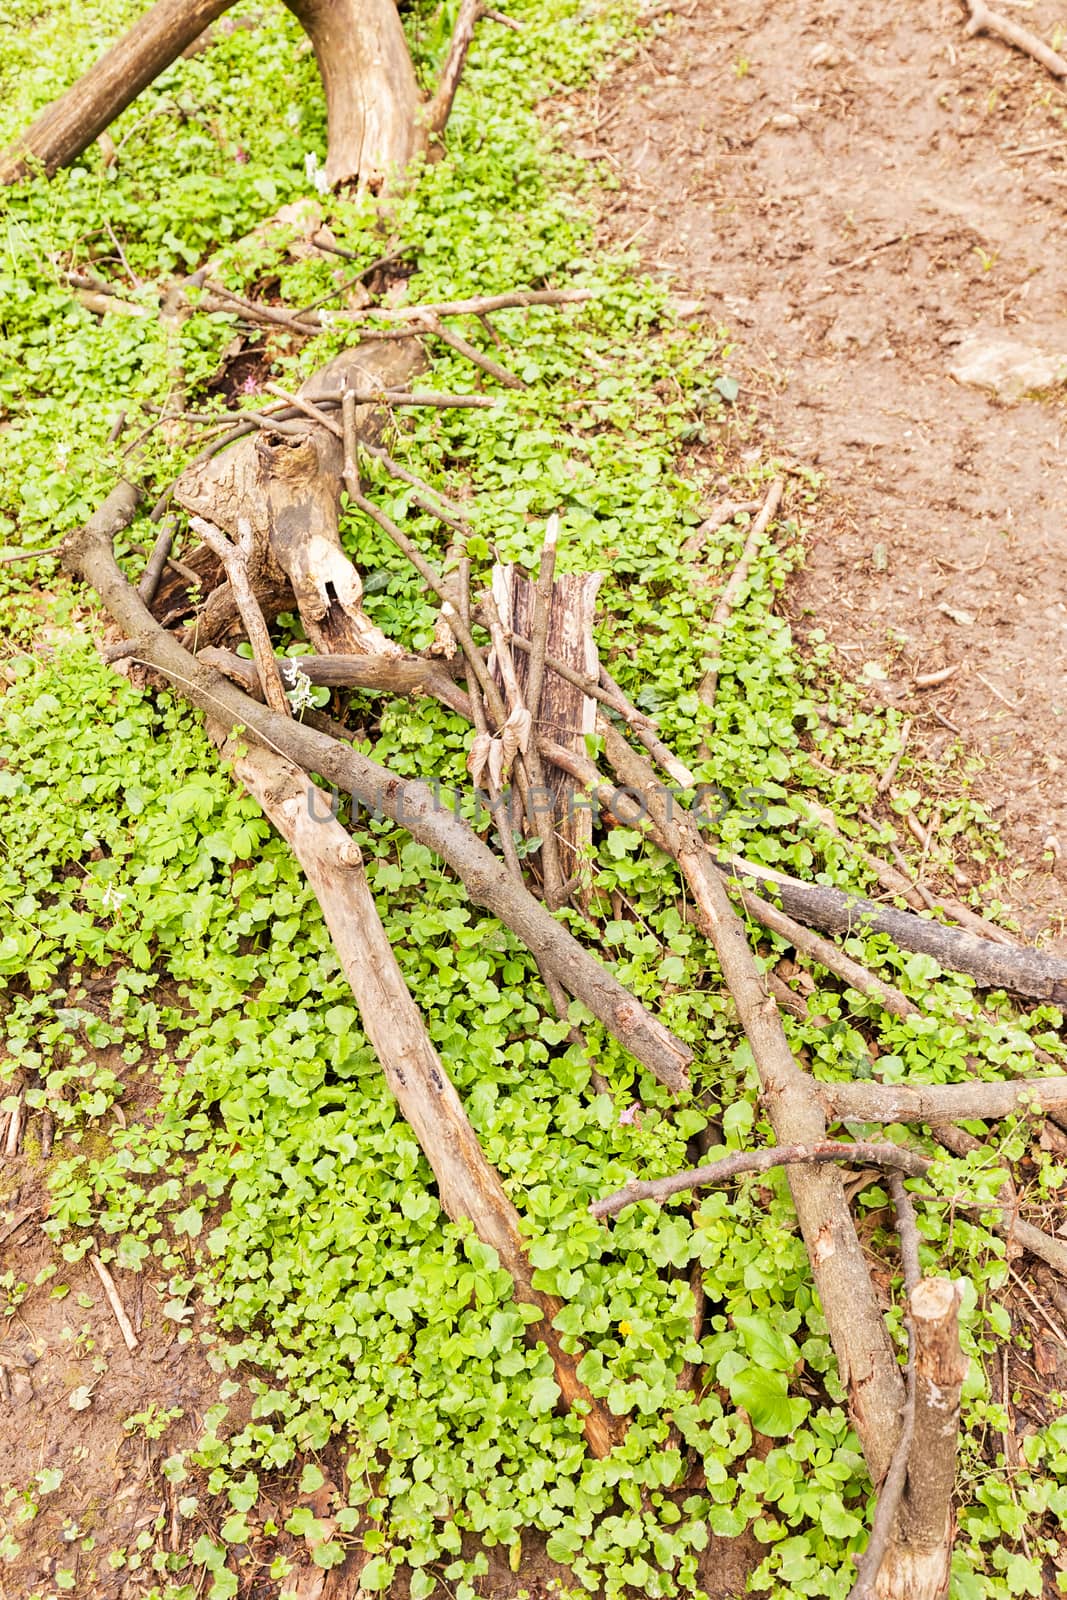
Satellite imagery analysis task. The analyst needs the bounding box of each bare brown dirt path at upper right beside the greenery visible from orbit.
[591,0,1067,939]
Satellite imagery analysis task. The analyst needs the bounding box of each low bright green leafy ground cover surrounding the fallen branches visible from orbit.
[0,0,1067,1600]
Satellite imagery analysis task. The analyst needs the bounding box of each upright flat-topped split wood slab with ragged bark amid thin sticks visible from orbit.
[493,565,603,902]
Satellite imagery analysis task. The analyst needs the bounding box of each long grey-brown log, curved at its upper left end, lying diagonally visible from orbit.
[64,482,693,1093]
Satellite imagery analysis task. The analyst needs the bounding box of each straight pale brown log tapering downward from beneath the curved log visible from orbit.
[214,731,622,1456]
